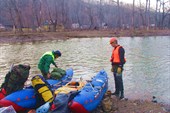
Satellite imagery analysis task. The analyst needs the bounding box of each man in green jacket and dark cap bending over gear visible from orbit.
[38,50,61,79]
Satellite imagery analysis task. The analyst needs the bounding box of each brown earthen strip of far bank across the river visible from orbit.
[0,29,170,43]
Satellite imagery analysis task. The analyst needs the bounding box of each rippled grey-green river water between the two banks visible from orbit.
[0,36,170,104]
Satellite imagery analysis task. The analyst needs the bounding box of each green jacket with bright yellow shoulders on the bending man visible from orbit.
[38,52,56,74]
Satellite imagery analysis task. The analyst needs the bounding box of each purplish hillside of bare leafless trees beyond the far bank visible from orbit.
[0,0,170,32]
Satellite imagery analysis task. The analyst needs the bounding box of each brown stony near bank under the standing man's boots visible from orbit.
[93,96,170,113]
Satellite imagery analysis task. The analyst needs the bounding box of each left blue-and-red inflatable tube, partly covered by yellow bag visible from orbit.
[0,68,73,111]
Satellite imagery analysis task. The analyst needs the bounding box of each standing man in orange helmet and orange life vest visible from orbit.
[110,38,126,99]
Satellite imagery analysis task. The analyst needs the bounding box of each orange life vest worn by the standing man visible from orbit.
[110,46,126,63]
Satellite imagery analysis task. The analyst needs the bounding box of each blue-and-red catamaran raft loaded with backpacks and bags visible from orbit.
[0,64,108,113]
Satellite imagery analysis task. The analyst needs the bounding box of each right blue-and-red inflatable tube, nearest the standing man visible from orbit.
[69,70,108,113]
